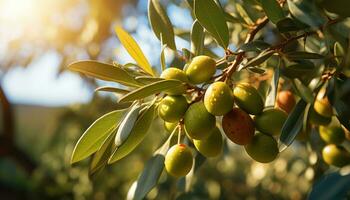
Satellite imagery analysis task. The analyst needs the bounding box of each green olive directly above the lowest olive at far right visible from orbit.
[318,125,345,144]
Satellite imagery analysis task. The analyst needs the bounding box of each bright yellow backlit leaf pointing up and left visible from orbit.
[115,27,154,76]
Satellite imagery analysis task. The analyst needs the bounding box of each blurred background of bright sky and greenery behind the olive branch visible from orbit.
[0,0,317,199]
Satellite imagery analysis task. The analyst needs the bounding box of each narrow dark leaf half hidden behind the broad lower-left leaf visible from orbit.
[89,131,115,176]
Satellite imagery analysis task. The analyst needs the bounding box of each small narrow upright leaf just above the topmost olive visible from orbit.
[191,20,204,56]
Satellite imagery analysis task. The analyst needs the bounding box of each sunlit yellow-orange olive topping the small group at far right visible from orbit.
[314,89,333,117]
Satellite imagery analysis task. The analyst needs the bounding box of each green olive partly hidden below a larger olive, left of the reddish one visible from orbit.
[193,127,223,157]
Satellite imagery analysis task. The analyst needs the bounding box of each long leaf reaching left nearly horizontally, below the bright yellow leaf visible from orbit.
[68,60,141,87]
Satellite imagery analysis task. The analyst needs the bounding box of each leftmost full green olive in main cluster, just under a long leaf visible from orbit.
[158,95,188,122]
